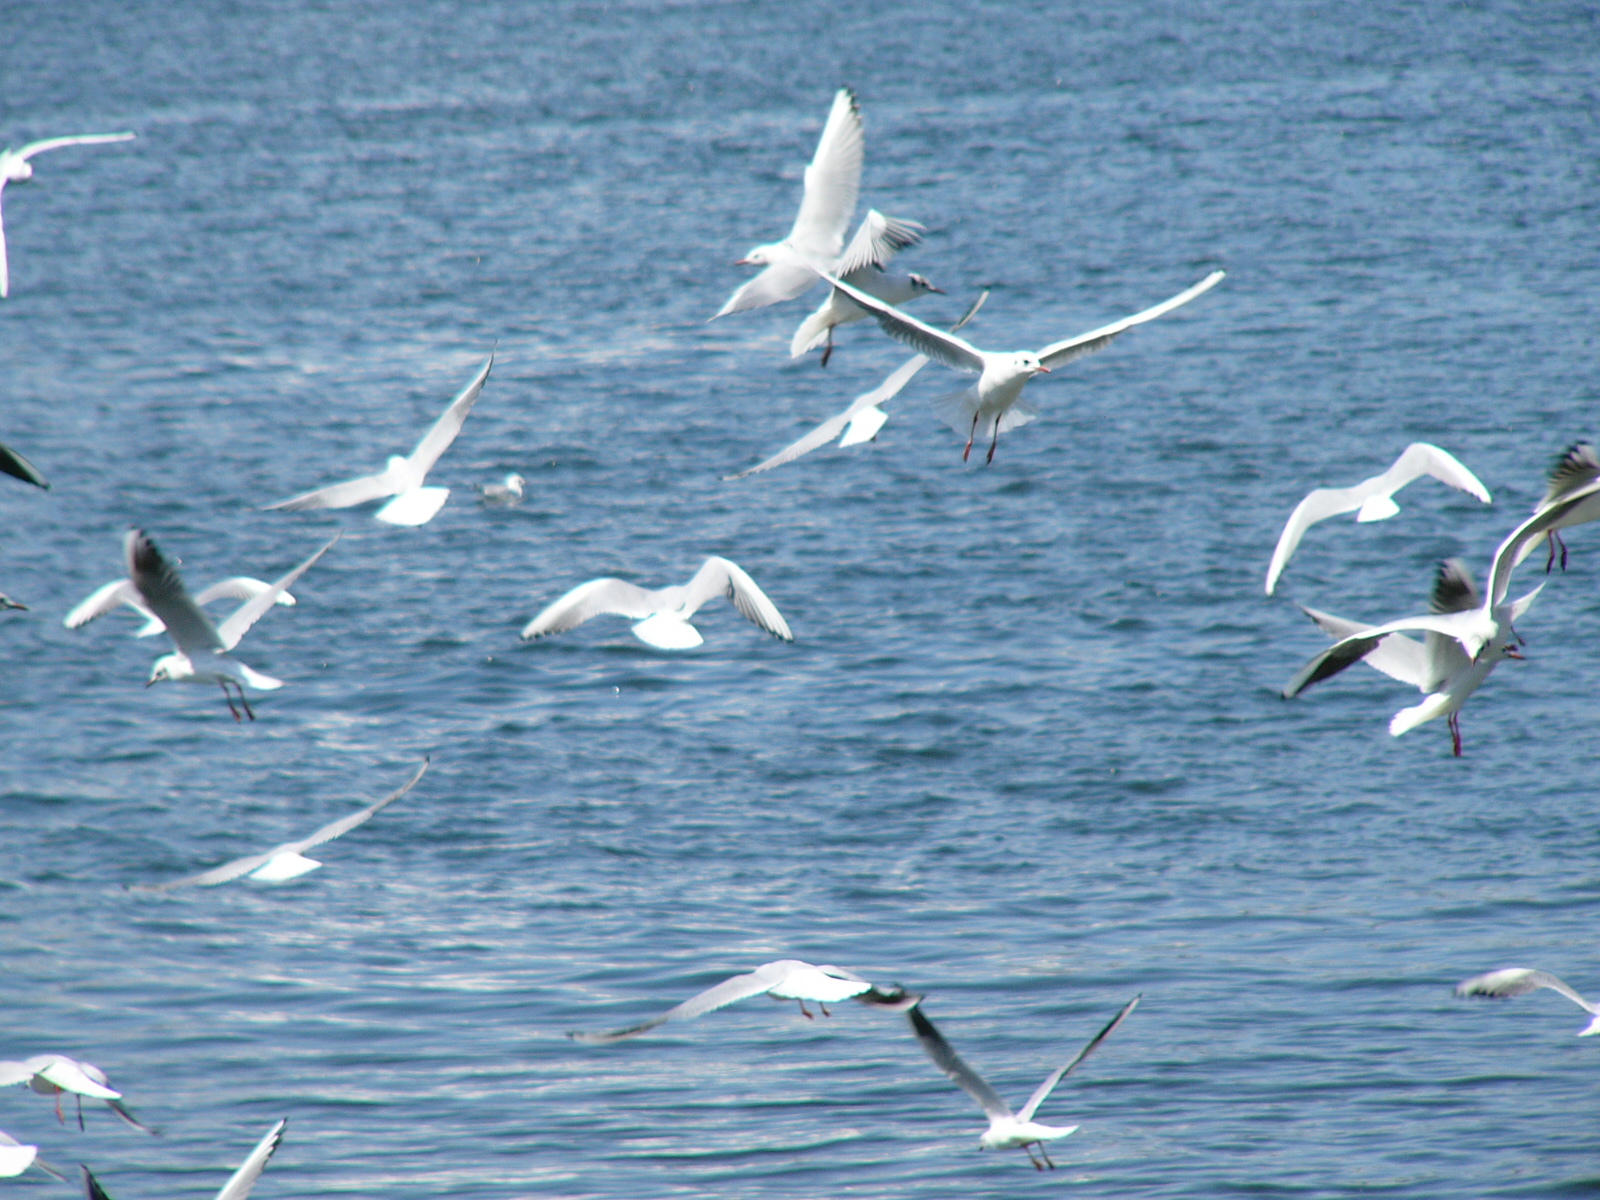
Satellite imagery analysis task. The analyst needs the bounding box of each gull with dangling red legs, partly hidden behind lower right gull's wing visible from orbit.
[1283,558,1544,758]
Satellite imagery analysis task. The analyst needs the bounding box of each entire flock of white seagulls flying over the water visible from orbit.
[0,88,1600,1200]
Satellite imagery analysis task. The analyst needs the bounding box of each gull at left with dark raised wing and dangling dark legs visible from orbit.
[123,530,339,722]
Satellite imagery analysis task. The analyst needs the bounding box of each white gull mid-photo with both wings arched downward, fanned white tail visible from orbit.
[522,555,795,650]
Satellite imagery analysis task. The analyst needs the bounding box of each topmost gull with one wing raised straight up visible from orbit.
[712,88,878,320]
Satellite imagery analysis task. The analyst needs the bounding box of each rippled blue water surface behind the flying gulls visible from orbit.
[0,0,1600,1200]
